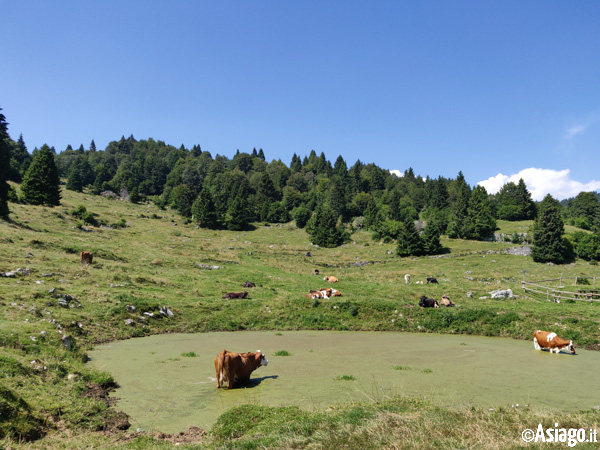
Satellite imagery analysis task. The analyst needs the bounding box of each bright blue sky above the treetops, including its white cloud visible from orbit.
[0,0,600,198]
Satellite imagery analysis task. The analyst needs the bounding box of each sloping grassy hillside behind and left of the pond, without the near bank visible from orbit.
[0,190,600,446]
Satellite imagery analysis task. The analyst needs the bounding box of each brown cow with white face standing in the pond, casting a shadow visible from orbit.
[215,350,269,389]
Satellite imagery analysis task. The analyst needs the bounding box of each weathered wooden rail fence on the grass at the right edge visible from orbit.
[522,277,600,303]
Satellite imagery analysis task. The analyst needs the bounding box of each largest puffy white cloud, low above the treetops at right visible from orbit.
[477,167,600,201]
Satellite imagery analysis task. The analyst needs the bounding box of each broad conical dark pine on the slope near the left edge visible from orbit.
[21,144,60,206]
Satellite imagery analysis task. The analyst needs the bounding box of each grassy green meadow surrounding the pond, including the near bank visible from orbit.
[0,186,600,448]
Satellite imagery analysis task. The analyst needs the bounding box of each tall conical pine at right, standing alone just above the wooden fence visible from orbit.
[531,194,568,263]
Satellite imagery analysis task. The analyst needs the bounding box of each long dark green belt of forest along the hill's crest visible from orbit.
[0,107,600,262]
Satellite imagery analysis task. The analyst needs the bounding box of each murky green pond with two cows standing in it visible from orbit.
[89,331,600,433]
